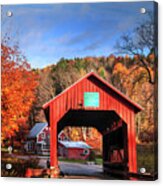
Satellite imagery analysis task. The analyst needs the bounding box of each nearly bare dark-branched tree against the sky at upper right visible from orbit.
[115,12,158,84]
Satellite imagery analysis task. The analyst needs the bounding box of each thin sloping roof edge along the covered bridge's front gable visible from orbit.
[43,72,143,111]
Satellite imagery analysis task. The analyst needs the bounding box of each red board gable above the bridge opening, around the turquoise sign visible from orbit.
[44,73,141,123]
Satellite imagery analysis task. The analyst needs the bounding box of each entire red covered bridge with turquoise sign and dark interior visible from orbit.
[43,72,142,177]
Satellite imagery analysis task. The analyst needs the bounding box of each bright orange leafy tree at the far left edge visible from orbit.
[1,44,38,144]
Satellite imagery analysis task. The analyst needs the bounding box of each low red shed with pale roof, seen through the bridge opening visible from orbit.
[58,141,91,160]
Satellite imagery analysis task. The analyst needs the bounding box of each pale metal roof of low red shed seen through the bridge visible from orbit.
[59,141,91,149]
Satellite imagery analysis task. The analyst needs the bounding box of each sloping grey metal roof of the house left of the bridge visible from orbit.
[27,123,48,138]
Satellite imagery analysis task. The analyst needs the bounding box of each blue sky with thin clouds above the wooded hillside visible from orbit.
[1,1,153,68]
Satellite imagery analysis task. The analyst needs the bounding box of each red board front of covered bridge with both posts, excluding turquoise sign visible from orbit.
[43,72,142,175]
